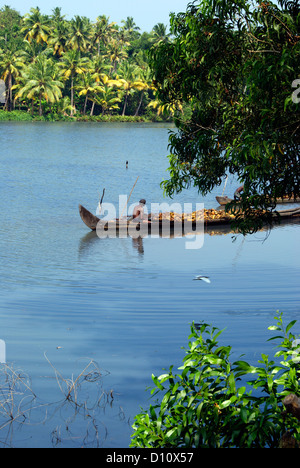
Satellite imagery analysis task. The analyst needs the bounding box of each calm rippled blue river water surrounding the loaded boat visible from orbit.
[0,123,300,448]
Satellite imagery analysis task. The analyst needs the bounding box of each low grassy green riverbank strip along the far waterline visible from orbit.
[0,110,170,123]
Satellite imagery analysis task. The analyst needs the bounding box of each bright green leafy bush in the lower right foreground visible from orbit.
[131,315,300,448]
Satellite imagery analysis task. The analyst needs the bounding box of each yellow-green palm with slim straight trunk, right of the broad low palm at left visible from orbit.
[59,49,90,116]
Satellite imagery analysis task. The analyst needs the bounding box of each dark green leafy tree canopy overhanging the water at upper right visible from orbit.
[150,0,300,233]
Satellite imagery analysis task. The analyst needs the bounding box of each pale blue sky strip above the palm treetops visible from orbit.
[0,0,191,32]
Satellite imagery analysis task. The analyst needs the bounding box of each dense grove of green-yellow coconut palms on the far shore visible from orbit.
[0,6,175,122]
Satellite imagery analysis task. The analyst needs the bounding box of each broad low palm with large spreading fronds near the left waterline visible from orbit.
[17,54,63,116]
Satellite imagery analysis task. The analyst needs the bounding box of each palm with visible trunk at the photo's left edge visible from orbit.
[0,48,24,111]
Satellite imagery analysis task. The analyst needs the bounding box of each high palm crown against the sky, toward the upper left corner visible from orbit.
[21,7,50,43]
